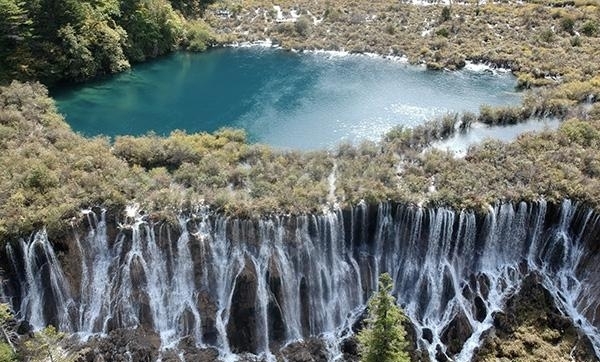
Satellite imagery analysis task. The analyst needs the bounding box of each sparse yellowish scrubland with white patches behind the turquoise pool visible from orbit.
[204,0,600,108]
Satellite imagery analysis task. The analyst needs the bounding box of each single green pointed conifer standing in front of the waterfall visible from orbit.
[358,273,410,362]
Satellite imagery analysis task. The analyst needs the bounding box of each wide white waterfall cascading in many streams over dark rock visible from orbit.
[1,200,600,361]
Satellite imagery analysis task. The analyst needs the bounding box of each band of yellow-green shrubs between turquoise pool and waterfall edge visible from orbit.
[0,82,600,240]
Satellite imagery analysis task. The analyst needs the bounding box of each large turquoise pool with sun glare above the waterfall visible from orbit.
[53,48,519,149]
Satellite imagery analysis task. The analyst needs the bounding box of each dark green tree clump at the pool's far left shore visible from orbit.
[0,0,212,84]
